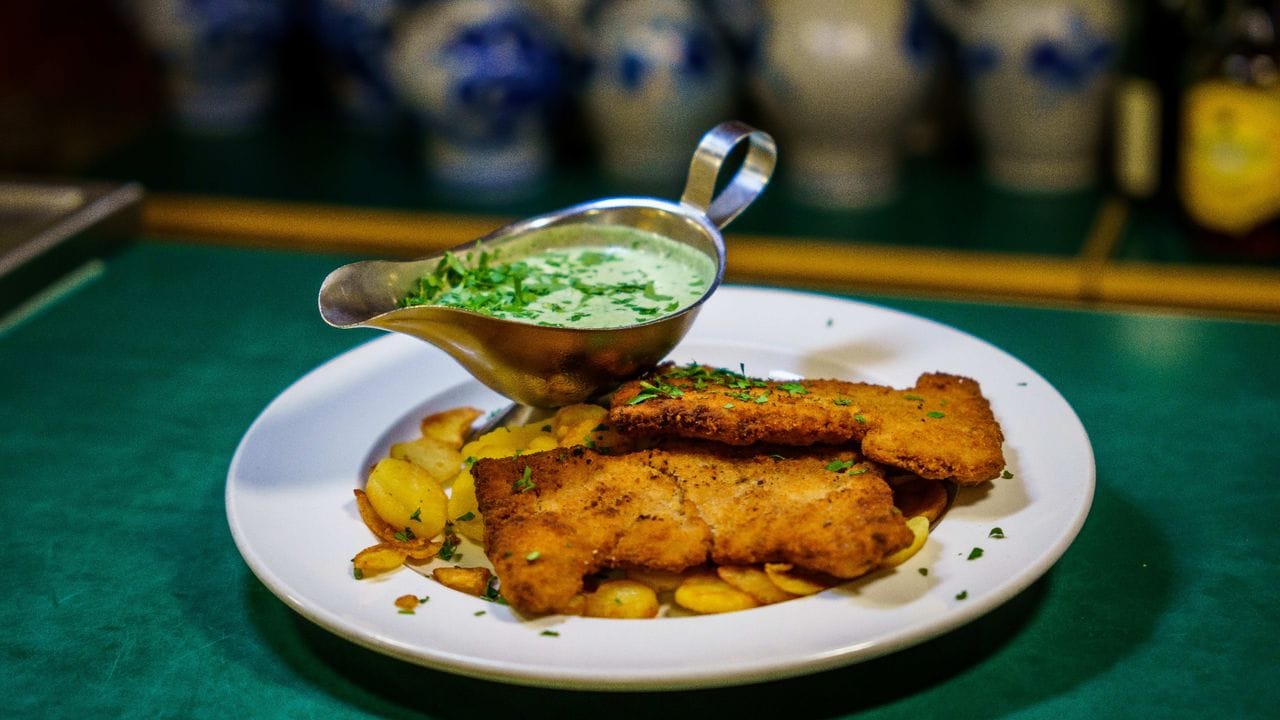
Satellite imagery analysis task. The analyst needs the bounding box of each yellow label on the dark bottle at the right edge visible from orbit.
[1181,81,1280,233]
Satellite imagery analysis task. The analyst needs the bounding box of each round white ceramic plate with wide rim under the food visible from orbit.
[227,287,1094,689]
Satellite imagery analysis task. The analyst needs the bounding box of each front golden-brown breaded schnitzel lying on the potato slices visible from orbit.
[471,442,913,612]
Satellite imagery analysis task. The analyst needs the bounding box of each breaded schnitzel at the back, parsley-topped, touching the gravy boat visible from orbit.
[609,364,1005,484]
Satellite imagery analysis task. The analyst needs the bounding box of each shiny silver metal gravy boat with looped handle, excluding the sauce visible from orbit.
[320,122,777,407]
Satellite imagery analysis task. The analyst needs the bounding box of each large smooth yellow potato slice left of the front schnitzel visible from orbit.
[365,457,448,539]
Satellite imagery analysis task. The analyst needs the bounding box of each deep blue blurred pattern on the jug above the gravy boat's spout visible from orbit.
[435,13,563,143]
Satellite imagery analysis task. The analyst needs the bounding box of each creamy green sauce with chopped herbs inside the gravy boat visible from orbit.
[401,224,716,328]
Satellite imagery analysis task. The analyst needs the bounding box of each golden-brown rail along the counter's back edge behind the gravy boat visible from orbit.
[142,195,1280,319]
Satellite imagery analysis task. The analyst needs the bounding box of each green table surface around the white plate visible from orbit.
[0,240,1280,720]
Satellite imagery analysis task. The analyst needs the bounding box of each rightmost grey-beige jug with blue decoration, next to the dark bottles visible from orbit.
[933,0,1124,191]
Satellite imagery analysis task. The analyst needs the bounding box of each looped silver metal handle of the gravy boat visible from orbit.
[680,120,778,228]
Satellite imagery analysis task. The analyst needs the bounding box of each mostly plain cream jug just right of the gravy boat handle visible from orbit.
[751,0,934,208]
